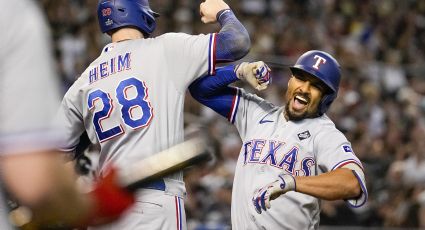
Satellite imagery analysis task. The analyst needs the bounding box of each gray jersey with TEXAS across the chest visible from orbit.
[229,89,367,230]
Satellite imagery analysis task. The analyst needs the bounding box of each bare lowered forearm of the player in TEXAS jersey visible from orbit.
[296,169,361,200]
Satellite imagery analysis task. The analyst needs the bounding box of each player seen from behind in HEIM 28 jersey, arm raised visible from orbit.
[54,0,250,229]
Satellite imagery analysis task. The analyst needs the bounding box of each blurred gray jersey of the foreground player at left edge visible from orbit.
[0,0,59,229]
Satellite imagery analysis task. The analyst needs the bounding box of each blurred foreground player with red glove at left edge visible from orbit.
[0,0,134,229]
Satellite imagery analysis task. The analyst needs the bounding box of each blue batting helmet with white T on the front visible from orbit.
[290,50,341,115]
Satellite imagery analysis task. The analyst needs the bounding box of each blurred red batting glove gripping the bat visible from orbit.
[81,168,135,225]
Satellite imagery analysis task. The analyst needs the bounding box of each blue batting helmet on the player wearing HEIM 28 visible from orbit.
[97,0,159,37]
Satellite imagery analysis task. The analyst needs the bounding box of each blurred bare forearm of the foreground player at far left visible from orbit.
[2,151,91,224]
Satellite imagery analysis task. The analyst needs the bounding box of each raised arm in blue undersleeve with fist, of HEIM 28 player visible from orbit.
[199,0,251,62]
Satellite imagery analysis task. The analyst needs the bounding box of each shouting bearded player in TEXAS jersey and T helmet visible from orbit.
[189,50,367,229]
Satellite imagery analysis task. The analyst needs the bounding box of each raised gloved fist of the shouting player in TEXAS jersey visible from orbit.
[235,61,271,91]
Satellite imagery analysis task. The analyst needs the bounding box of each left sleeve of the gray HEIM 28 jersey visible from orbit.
[55,85,85,152]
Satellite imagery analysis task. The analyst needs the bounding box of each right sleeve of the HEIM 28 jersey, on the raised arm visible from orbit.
[164,33,216,92]
